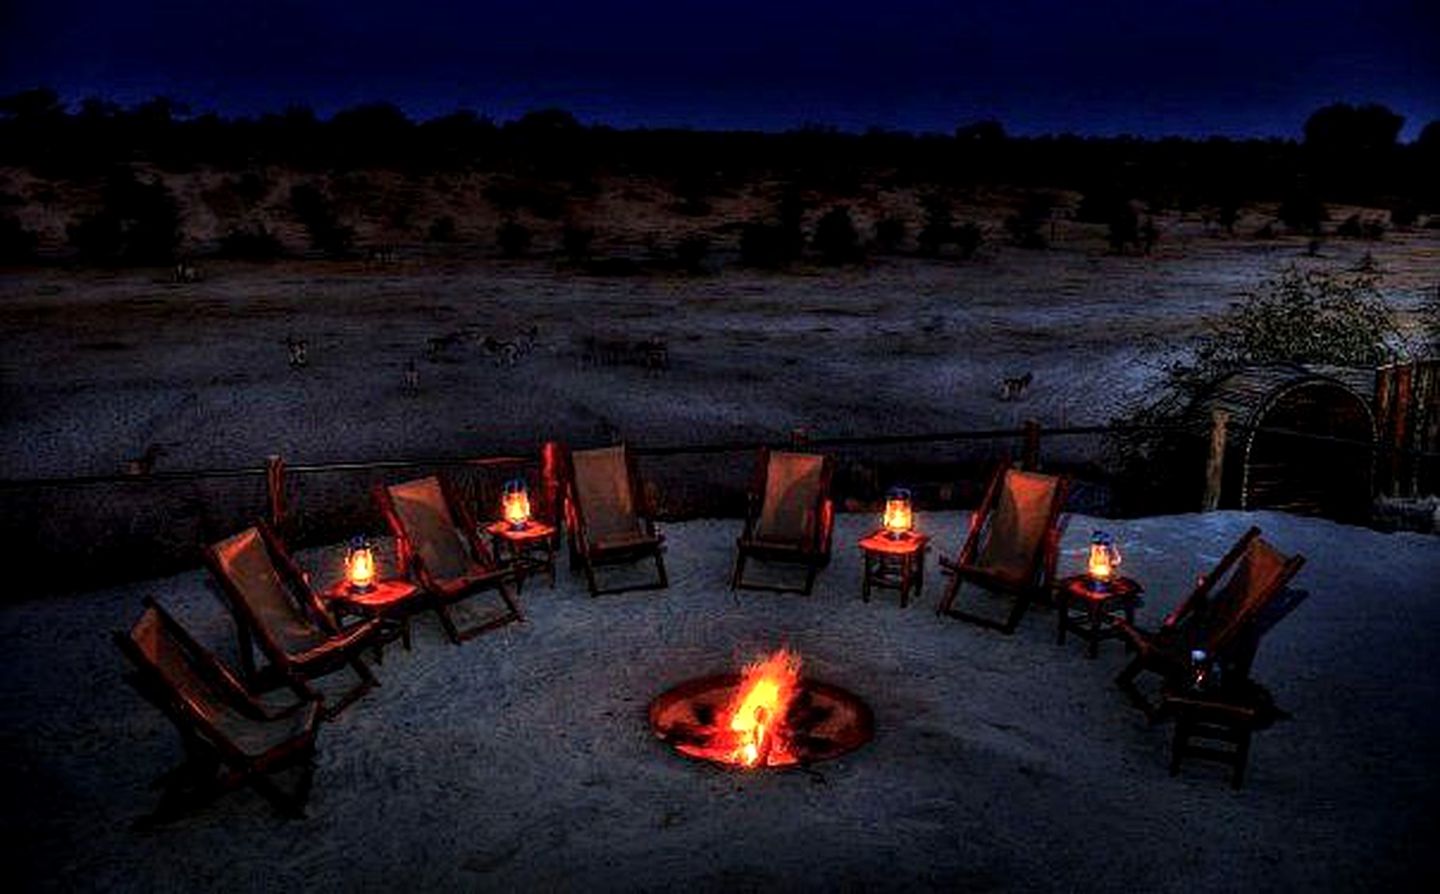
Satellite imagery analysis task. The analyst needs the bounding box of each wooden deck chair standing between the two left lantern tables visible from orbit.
[376,475,526,644]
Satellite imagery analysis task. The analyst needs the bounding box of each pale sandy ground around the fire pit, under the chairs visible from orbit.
[0,513,1440,891]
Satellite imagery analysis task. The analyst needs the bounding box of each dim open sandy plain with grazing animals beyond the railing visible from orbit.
[0,220,1440,477]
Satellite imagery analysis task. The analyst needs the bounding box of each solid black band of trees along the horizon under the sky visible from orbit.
[0,88,1440,200]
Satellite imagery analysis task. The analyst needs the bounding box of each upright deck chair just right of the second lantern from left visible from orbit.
[564,445,670,596]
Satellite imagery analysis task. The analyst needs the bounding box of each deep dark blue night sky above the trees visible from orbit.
[0,0,1440,140]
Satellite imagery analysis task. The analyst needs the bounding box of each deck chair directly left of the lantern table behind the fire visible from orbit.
[730,448,835,596]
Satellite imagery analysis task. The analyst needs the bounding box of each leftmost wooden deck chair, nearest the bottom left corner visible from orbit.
[115,597,320,825]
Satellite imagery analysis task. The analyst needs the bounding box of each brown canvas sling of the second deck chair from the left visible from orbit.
[210,528,328,655]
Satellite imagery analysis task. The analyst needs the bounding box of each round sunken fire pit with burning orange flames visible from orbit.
[649,649,874,769]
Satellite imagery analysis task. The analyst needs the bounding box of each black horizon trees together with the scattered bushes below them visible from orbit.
[0,88,1440,269]
